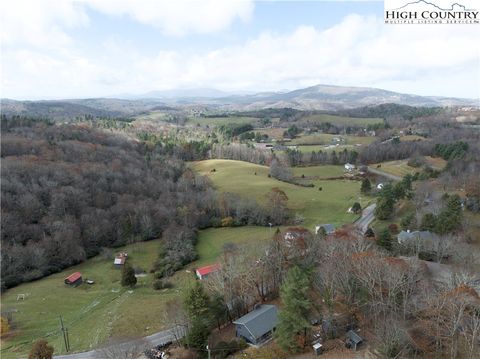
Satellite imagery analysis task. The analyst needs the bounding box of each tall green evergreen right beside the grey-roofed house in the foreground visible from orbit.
[275,267,312,351]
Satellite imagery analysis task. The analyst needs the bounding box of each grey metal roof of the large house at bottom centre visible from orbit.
[233,304,278,338]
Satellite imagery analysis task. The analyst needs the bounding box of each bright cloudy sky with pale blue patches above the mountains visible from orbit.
[0,0,480,99]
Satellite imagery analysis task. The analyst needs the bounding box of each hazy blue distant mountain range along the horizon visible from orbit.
[1,85,480,118]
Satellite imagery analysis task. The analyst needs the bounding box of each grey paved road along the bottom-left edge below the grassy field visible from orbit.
[53,327,185,359]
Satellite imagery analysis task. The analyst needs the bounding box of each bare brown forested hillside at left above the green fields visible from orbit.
[1,117,267,289]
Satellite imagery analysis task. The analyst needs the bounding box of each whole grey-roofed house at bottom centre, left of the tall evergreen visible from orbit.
[233,304,278,344]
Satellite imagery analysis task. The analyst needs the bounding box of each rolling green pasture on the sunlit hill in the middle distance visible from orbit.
[191,160,368,229]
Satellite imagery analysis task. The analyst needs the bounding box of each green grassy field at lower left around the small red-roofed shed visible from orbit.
[1,240,192,359]
